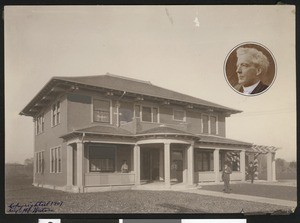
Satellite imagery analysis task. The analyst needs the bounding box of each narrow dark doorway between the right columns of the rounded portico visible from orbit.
[171,150,183,183]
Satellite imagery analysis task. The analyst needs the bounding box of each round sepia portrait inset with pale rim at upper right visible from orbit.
[224,42,276,96]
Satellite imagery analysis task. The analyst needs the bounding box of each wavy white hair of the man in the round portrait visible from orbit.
[236,47,270,74]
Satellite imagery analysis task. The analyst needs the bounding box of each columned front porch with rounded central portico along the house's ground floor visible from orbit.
[61,129,274,193]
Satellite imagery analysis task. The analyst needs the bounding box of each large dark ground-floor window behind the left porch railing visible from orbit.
[89,146,115,172]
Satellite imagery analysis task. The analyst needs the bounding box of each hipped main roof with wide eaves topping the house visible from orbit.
[20,74,241,116]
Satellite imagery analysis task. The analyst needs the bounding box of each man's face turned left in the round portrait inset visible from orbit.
[236,54,261,87]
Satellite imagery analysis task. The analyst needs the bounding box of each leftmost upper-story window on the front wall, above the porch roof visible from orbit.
[93,99,110,123]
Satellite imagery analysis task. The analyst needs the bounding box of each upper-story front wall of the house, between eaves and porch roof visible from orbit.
[67,91,225,136]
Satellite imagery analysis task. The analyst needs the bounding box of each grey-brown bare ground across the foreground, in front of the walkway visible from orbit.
[5,178,296,213]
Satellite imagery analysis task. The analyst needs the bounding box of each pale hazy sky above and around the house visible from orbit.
[4,5,296,163]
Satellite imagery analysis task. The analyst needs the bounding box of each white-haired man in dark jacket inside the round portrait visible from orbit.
[235,47,269,95]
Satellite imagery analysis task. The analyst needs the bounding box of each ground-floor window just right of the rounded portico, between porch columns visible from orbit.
[195,150,214,171]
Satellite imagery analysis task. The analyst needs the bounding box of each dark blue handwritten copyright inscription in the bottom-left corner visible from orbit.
[8,201,63,214]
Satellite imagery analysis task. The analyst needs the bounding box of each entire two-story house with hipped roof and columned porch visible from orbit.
[20,74,274,192]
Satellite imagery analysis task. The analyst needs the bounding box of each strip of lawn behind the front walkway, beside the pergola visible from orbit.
[202,183,297,201]
